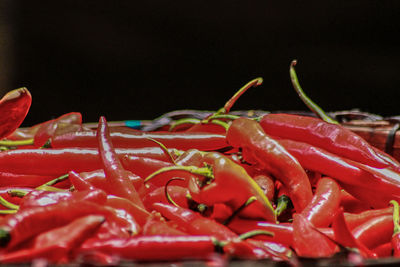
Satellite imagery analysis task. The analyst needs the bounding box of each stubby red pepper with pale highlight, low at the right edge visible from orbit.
[352,214,393,249]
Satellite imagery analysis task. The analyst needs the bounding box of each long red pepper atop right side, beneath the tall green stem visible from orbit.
[260,113,388,168]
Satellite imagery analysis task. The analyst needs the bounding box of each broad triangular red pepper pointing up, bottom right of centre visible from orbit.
[293,214,338,258]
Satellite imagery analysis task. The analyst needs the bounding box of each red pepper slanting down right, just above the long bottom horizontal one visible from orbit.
[153,203,237,241]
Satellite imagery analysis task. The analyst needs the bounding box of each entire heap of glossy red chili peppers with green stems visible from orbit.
[0,63,400,265]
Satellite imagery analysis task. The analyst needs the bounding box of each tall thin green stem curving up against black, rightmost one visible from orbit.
[289,60,339,124]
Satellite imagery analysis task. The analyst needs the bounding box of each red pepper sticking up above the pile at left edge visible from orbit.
[0,87,32,139]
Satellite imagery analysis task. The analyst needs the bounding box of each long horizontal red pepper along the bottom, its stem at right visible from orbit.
[80,235,215,262]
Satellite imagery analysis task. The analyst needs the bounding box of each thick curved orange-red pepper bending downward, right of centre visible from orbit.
[226,118,312,212]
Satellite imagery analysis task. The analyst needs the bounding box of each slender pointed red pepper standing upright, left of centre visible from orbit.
[97,117,144,208]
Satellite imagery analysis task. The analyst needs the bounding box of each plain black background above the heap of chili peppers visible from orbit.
[0,0,400,125]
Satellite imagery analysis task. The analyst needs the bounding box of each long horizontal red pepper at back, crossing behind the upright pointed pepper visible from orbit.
[51,128,227,150]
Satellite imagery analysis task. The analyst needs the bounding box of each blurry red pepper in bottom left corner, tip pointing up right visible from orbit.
[0,215,105,264]
